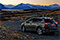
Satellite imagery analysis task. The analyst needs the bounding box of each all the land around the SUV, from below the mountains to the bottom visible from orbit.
[0,9,60,40]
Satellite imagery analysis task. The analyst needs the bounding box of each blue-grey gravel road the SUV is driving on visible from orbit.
[0,21,60,40]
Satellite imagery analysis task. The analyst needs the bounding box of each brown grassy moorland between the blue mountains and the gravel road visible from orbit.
[0,9,60,21]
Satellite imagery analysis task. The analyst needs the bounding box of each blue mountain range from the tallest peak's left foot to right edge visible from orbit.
[12,3,60,10]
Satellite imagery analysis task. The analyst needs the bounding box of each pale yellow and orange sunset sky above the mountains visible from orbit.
[0,0,60,5]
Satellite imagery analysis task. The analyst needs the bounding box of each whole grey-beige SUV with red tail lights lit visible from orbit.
[21,17,58,35]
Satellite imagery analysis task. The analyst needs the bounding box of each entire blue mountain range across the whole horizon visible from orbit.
[0,3,60,10]
